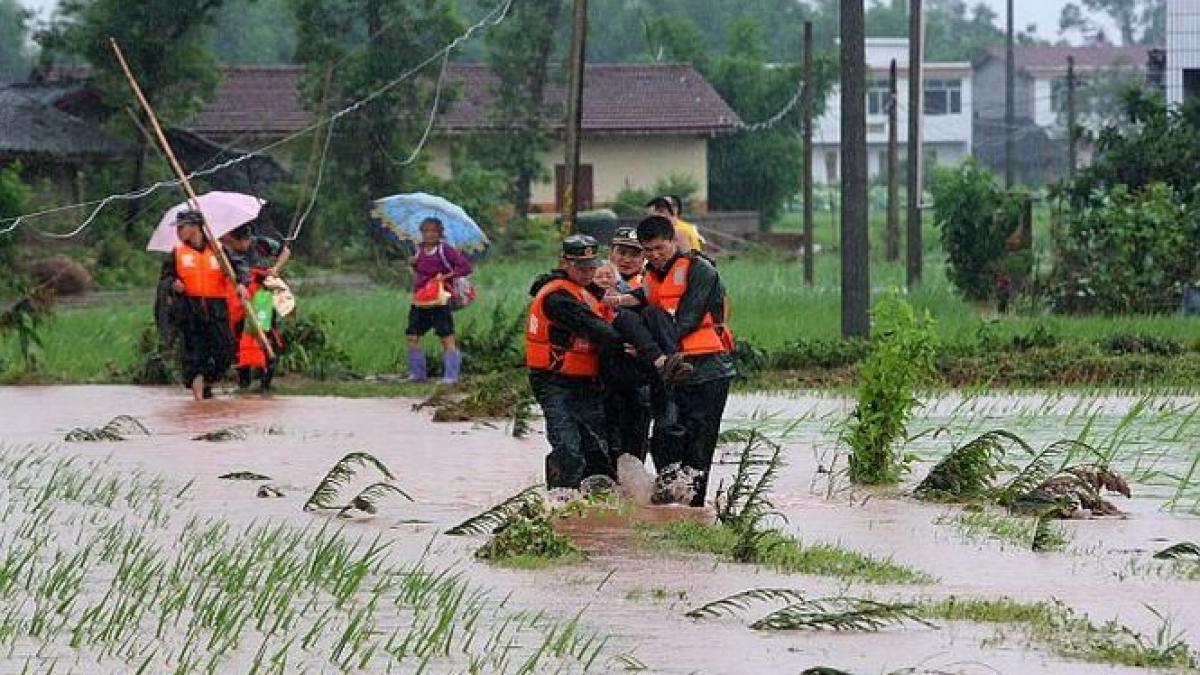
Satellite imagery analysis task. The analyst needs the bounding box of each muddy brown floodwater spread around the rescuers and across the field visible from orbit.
[0,387,1200,674]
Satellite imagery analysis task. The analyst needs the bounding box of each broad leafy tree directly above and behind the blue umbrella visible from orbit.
[292,0,463,243]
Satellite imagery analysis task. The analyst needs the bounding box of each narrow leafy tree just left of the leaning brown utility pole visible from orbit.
[480,0,563,215]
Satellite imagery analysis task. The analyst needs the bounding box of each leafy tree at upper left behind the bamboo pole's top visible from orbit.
[40,0,234,238]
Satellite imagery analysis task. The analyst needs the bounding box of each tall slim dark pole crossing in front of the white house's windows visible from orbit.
[905,0,925,289]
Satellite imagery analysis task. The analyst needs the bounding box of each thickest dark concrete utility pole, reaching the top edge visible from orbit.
[841,0,871,338]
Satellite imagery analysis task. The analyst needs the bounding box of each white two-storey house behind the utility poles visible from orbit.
[812,37,972,184]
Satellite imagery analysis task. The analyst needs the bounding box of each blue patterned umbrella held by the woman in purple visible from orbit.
[371,192,491,257]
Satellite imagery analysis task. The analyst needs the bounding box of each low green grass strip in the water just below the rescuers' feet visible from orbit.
[640,522,936,584]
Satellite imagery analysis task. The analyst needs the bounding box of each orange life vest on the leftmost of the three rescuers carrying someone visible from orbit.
[526,279,606,377]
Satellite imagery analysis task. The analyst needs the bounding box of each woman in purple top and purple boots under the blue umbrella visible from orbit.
[404,216,472,384]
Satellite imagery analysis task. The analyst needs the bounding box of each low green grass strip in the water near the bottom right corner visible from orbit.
[917,597,1200,669]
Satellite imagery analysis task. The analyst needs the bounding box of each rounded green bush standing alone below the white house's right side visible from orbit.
[932,160,1021,300]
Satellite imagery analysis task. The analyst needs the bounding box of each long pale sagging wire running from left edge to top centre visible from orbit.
[0,0,514,239]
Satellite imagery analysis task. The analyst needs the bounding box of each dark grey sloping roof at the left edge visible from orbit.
[0,88,127,161]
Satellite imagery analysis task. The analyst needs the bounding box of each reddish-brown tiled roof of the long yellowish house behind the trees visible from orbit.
[187,64,738,137]
